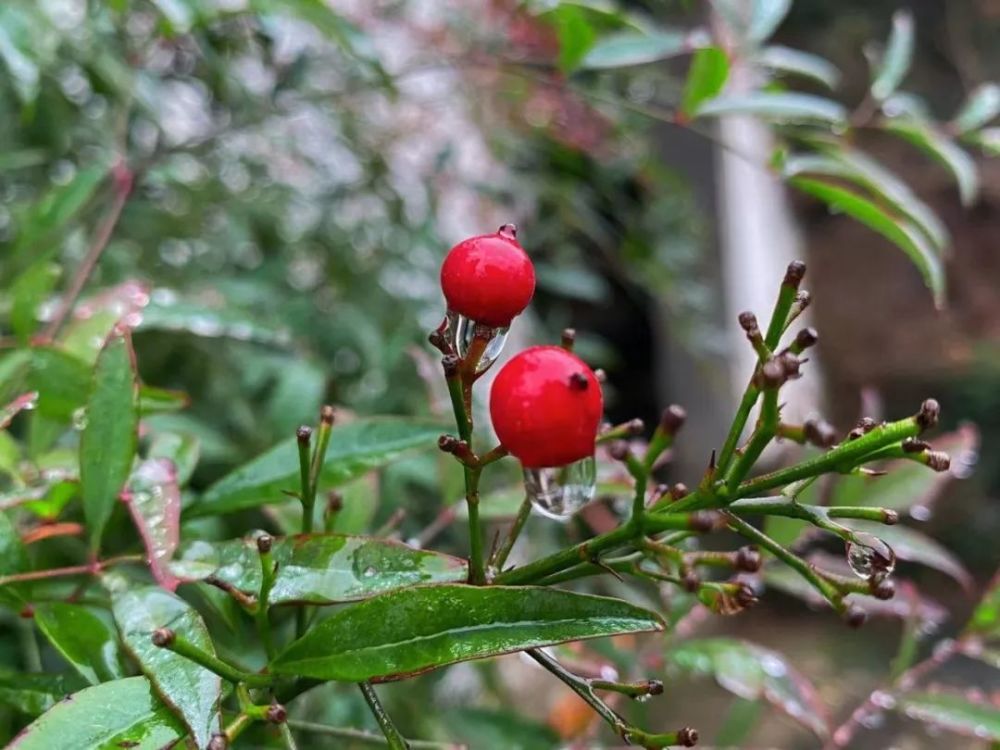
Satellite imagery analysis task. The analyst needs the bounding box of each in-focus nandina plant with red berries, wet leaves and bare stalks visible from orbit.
[0,225,1000,750]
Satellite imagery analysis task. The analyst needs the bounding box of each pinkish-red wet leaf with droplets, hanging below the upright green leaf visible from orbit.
[124,458,181,591]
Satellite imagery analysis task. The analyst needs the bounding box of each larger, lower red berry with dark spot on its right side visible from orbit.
[490,346,604,469]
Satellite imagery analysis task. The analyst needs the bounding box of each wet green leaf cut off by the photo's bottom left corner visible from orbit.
[7,677,187,750]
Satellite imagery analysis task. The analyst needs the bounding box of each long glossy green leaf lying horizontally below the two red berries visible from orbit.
[271,585,664,682]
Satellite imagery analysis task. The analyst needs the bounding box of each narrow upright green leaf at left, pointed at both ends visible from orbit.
[80,330,139,549]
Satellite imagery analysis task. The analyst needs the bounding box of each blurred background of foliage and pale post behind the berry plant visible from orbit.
[0,0,1000,749]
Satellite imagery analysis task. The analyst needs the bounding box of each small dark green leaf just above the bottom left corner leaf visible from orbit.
[34,602,125,685]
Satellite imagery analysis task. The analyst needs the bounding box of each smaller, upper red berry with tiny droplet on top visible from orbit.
[441,224,535,328]
